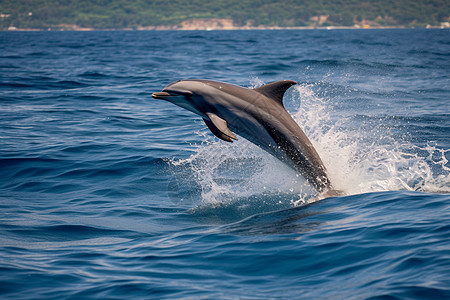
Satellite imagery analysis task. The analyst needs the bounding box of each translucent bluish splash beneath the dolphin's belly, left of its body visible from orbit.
[171,133,314,208]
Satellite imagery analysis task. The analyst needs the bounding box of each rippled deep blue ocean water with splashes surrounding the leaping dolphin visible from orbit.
[0,29,450,299]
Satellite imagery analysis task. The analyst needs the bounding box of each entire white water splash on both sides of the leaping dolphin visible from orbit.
[171,78,450,209]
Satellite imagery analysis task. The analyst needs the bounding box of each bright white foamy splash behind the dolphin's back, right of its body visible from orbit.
[292,84,450,194]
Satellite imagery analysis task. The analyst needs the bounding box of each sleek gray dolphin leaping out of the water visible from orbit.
[152,79,338,196]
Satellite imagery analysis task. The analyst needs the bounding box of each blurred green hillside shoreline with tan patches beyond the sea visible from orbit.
[0,0,450,30]
